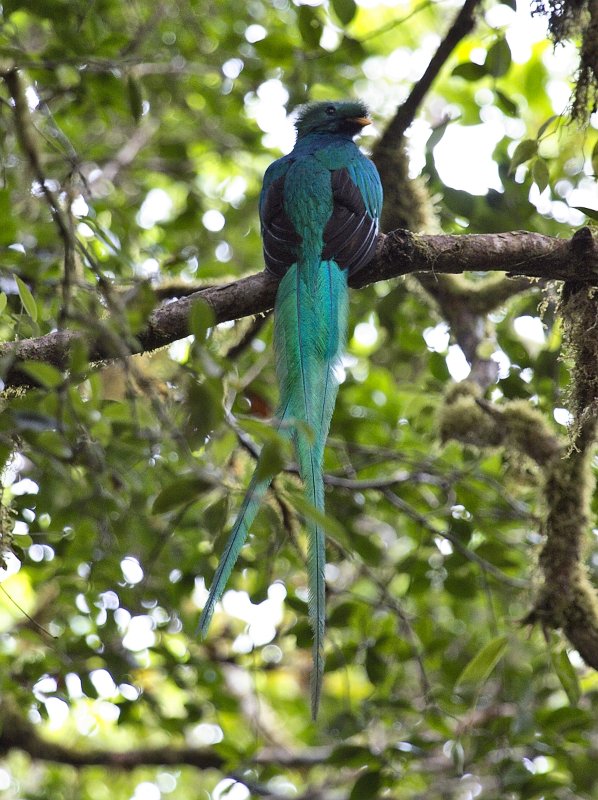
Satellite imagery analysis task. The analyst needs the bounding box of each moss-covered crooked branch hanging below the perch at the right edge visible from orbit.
[440,283,598,669]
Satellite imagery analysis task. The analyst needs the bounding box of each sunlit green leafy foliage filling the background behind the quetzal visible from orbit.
[0,0,598,800]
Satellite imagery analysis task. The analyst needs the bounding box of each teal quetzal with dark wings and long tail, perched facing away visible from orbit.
[199,101,382,718]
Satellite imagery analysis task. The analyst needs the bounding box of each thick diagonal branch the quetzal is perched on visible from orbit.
[0,228,598,387]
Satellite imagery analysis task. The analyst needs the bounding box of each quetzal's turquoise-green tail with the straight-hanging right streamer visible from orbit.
[274,259,348,719]
